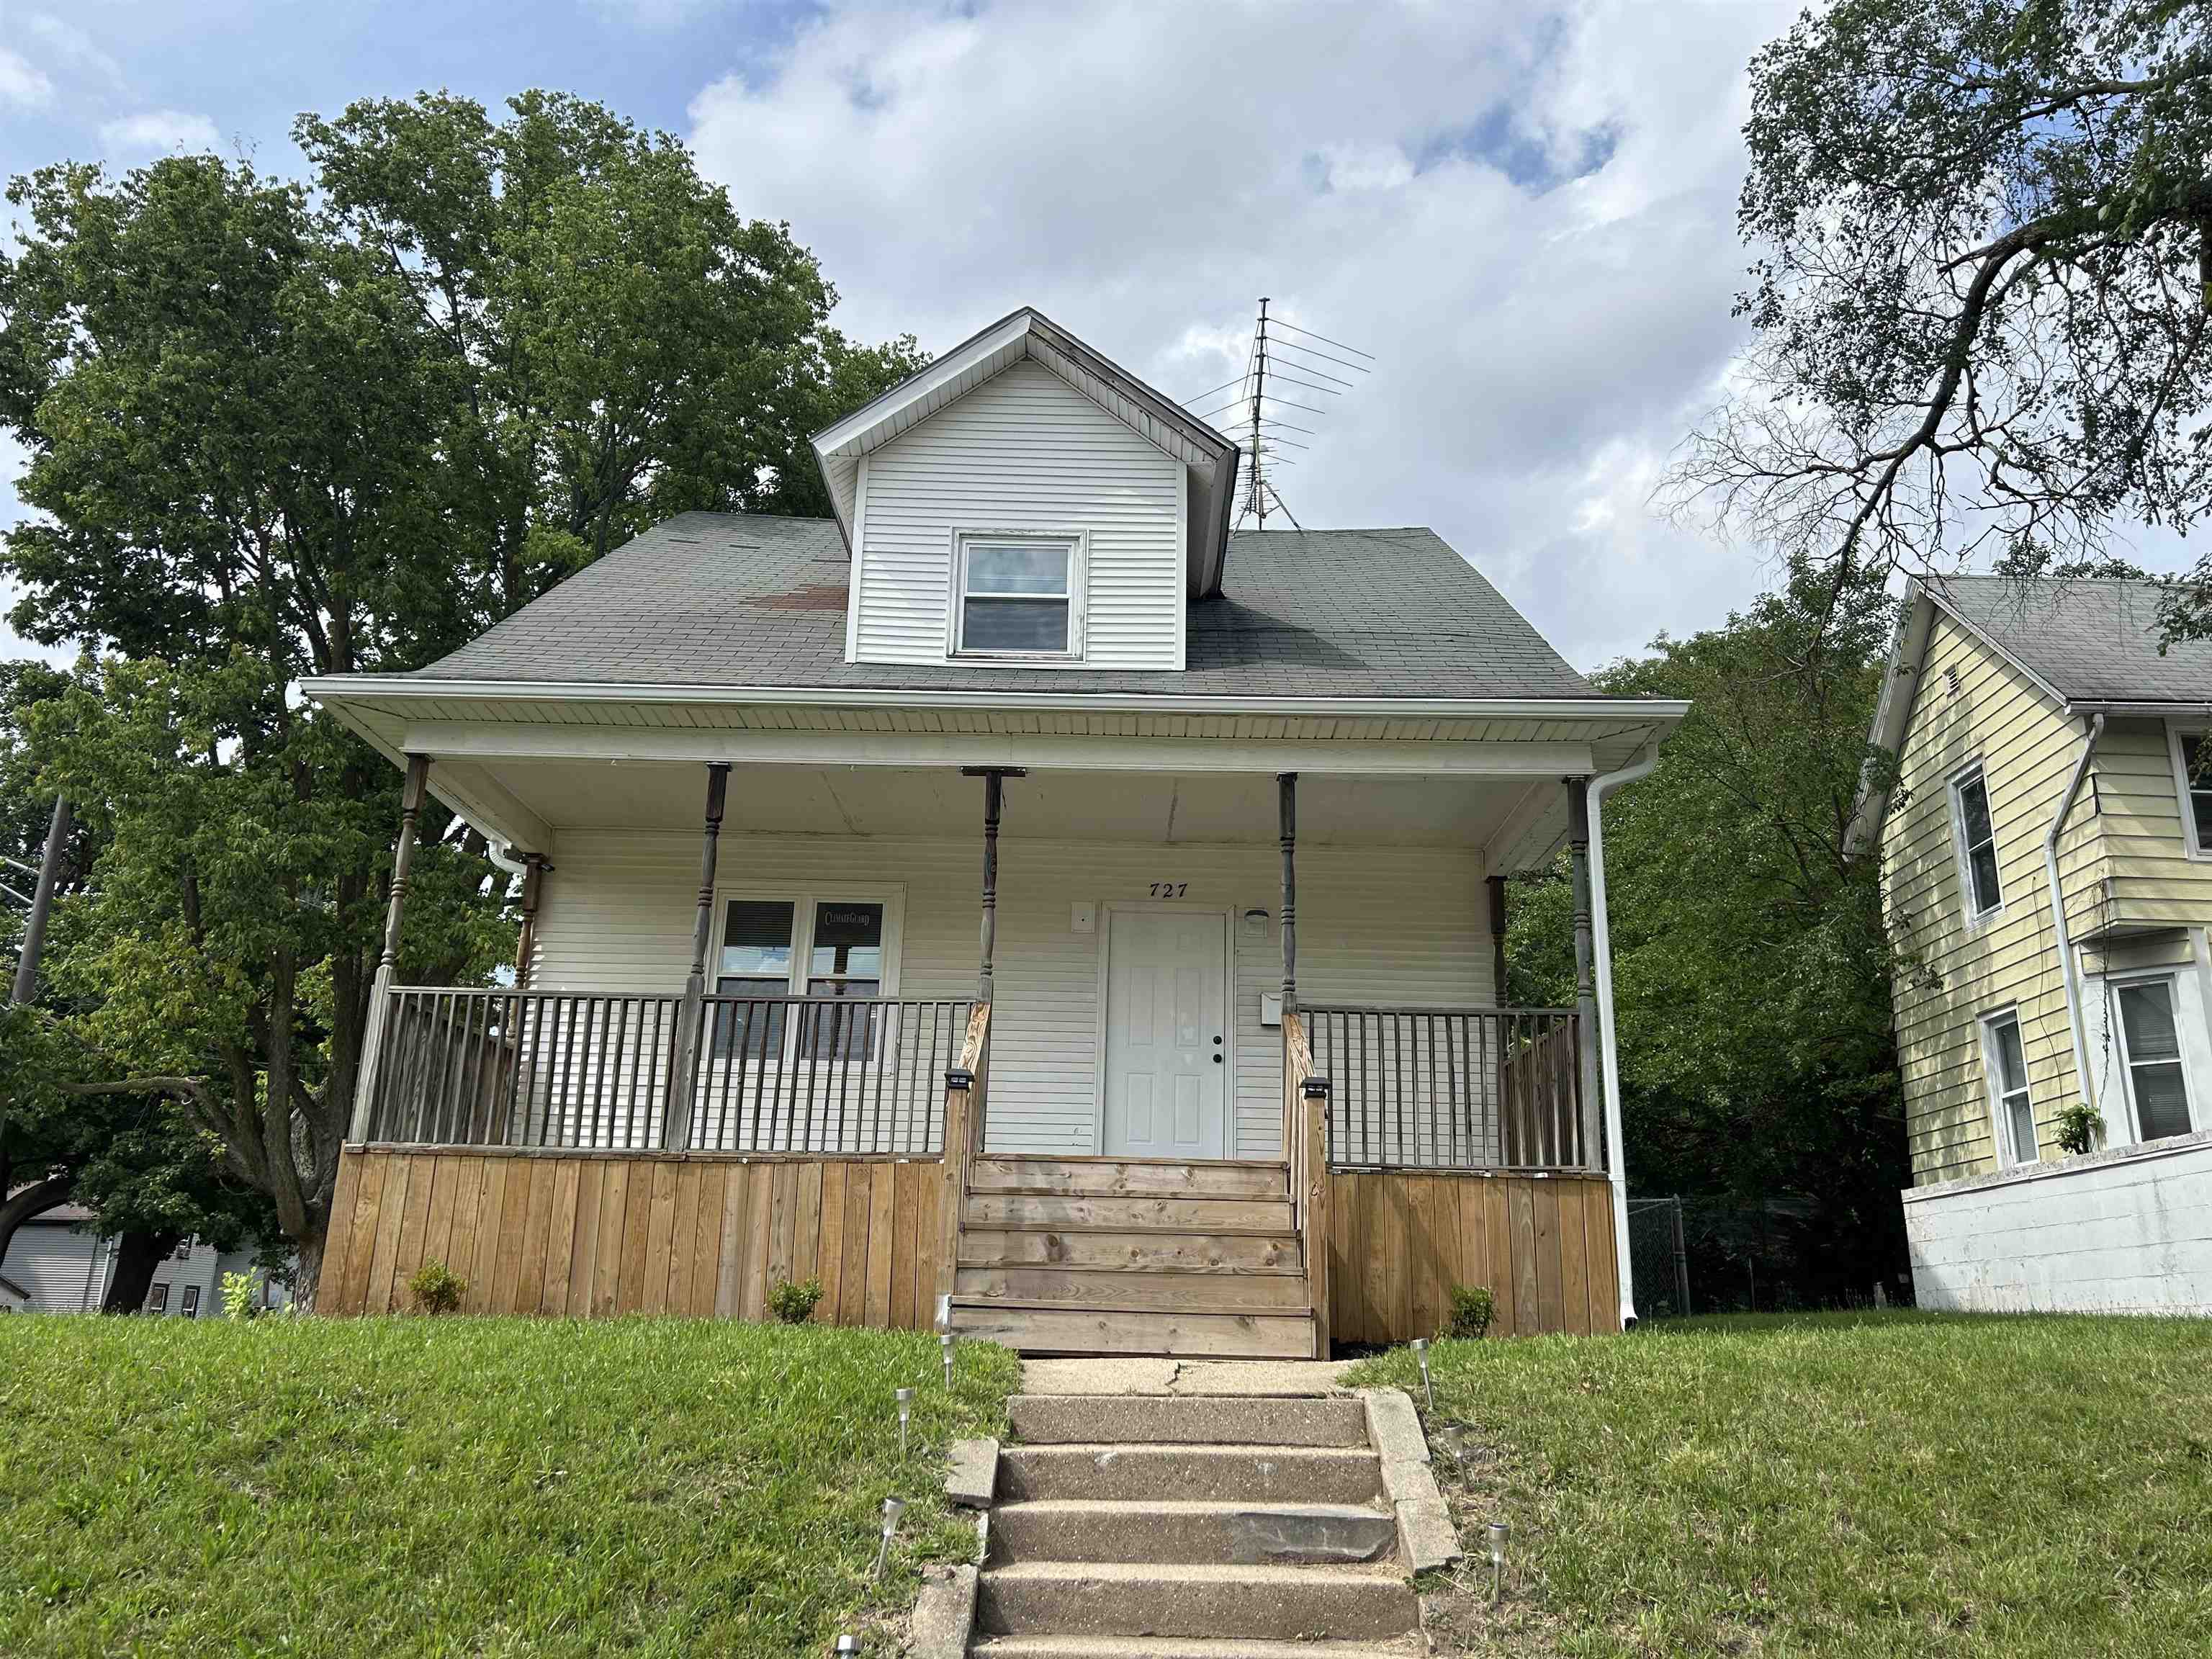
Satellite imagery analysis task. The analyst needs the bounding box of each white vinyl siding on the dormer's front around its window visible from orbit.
[850,363,1186,668]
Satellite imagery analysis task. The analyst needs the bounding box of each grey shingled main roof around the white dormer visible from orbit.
[416,513,1595,699]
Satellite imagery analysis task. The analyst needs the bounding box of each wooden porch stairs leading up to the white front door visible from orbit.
[953,1157,1314,1358]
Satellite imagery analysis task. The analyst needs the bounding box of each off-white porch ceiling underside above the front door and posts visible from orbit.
[475,759,1562,848]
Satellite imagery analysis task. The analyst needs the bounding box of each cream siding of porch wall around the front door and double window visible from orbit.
[531,832,1496,1159]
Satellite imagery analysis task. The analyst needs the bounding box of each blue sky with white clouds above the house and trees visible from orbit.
[0,0,1876,668]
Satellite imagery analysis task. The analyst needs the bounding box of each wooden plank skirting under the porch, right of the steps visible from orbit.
[1329,1170,1622,1343]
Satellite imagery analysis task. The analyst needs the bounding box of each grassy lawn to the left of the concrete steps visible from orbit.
[0,1316,1015,1659]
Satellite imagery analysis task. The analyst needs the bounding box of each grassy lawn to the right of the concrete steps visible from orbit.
[1354,1314,2212,1659]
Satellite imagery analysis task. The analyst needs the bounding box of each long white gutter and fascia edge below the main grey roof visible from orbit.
[301,675,1690,728]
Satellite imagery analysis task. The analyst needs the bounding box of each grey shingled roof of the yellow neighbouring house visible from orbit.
[1929,575,2212,703]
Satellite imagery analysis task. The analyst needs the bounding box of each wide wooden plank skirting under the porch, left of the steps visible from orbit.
[316,1146,943,1329]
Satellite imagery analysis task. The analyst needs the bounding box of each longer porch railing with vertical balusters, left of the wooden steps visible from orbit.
[367,986,974,1155]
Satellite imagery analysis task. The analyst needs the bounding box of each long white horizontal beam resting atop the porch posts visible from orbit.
[403,721,1595,783]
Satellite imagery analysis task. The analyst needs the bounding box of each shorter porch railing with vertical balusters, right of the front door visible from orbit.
[1303,1002,1597,1170]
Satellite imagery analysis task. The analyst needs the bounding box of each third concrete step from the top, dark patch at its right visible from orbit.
[991,1498,1398,1566]
